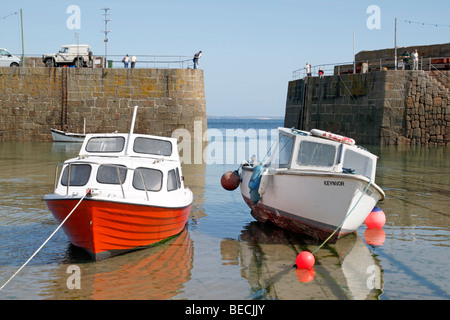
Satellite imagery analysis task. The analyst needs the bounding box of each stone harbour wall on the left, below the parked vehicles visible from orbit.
[0,67,207,141]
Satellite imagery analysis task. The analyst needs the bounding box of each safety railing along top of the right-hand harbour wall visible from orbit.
[292,56,450,80]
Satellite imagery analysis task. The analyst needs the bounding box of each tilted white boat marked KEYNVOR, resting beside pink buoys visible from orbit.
[240,128,385,242]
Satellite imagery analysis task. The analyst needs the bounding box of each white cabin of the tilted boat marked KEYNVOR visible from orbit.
[265,128,377,181]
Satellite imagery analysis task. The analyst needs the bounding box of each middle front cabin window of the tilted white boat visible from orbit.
[297,141,336,167]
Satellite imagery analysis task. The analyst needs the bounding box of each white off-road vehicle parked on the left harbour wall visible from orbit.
[42,44,92,67]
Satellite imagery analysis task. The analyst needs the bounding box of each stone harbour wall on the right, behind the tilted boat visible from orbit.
[285,70,450,145]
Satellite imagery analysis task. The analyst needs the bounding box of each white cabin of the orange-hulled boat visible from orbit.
[51,134,184,205]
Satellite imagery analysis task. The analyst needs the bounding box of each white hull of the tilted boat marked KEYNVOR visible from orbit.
[241,167,383,242]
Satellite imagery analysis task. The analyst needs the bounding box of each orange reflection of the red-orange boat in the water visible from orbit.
[46,229,193,300]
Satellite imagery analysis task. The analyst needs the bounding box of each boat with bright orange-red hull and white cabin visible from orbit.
[43,108,193,260]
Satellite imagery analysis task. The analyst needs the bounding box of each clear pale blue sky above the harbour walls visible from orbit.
[0,0,450,117]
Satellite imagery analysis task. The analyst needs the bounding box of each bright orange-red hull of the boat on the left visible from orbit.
[45,198,191,260]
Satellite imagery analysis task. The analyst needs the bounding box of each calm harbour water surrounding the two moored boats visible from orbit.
[0,119,450,300]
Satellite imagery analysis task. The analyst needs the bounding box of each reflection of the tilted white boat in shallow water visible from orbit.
[221,222,382,300]
